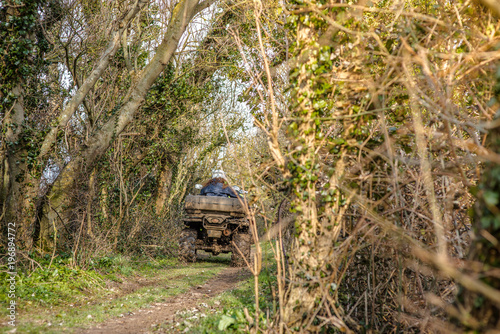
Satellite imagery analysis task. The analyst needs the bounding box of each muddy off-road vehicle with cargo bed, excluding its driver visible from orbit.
[179,195,251,267]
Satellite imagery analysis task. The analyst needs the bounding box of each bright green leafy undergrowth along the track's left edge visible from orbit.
[0,254,186,314]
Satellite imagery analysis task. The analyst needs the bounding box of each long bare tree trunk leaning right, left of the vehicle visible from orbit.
[38,0,214,250]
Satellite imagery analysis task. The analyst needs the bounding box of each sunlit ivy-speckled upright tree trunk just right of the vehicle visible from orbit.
[283,24,339,332]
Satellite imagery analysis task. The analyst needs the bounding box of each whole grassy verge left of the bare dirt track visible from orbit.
[0,252,229,333]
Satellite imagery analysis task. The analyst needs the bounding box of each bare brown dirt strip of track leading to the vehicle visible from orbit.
[76,268,250,334]
